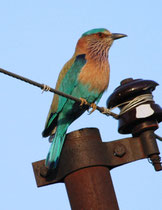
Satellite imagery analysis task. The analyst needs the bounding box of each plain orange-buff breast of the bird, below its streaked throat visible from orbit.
[78,61,109,93]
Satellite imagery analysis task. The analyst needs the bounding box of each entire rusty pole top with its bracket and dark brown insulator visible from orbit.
[33,78,162,210]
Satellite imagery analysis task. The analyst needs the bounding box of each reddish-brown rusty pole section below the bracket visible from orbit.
[64,166,119,210]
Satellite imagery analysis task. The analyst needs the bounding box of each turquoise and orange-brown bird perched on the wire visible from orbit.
[42,28,127,169]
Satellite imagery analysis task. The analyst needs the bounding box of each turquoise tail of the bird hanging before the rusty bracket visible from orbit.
[45,131,66,169]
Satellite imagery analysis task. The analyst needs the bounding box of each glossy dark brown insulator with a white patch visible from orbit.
[107,78,162,135]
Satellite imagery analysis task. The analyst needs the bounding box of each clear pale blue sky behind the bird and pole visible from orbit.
[0,0,162,210]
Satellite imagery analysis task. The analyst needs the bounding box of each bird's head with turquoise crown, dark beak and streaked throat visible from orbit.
[76,28,127,58]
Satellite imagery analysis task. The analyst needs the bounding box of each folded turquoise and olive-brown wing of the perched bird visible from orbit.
[42,54,86,137]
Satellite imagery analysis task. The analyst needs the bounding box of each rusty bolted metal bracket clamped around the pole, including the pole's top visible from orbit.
[32,128,159,187]
